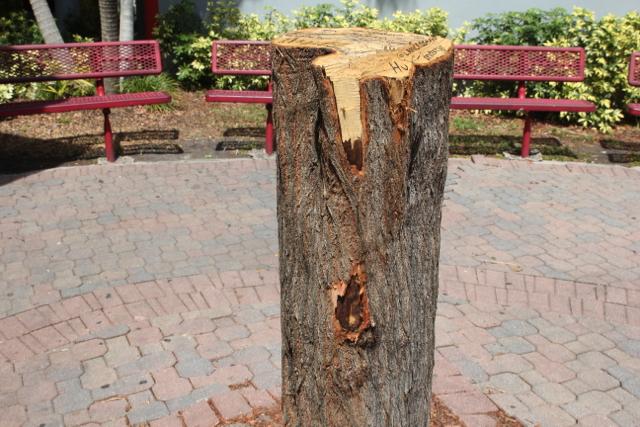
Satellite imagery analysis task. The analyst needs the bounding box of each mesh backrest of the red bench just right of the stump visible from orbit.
[453,45,585,82]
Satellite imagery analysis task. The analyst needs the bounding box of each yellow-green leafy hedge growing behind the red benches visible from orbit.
[0,0,640,132]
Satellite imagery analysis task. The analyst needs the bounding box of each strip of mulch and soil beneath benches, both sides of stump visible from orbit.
[0,91,640,173]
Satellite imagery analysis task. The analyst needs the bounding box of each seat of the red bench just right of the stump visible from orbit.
[451,97,596,113]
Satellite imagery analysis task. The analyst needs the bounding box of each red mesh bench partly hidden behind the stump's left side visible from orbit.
[205,40,274,154]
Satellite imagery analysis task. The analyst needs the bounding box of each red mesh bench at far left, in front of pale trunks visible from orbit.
[0,41,171,162]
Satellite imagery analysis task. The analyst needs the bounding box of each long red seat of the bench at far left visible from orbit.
[0,92,171,116]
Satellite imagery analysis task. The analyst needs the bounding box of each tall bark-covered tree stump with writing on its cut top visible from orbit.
[273,28,453,426]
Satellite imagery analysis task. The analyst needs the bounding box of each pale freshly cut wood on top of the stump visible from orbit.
[273,28,452,148]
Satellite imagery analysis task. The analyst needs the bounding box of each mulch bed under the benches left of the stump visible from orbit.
[0,91,266,173]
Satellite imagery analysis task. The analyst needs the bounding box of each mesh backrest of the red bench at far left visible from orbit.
[0,40,162,83]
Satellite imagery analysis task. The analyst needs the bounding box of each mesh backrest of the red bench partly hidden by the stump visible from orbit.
[211,40,271,76]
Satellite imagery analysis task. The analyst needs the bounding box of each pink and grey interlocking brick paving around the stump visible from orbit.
[0,157,640,426]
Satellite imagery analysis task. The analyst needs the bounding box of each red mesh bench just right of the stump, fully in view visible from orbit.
[451,45,596,157]
